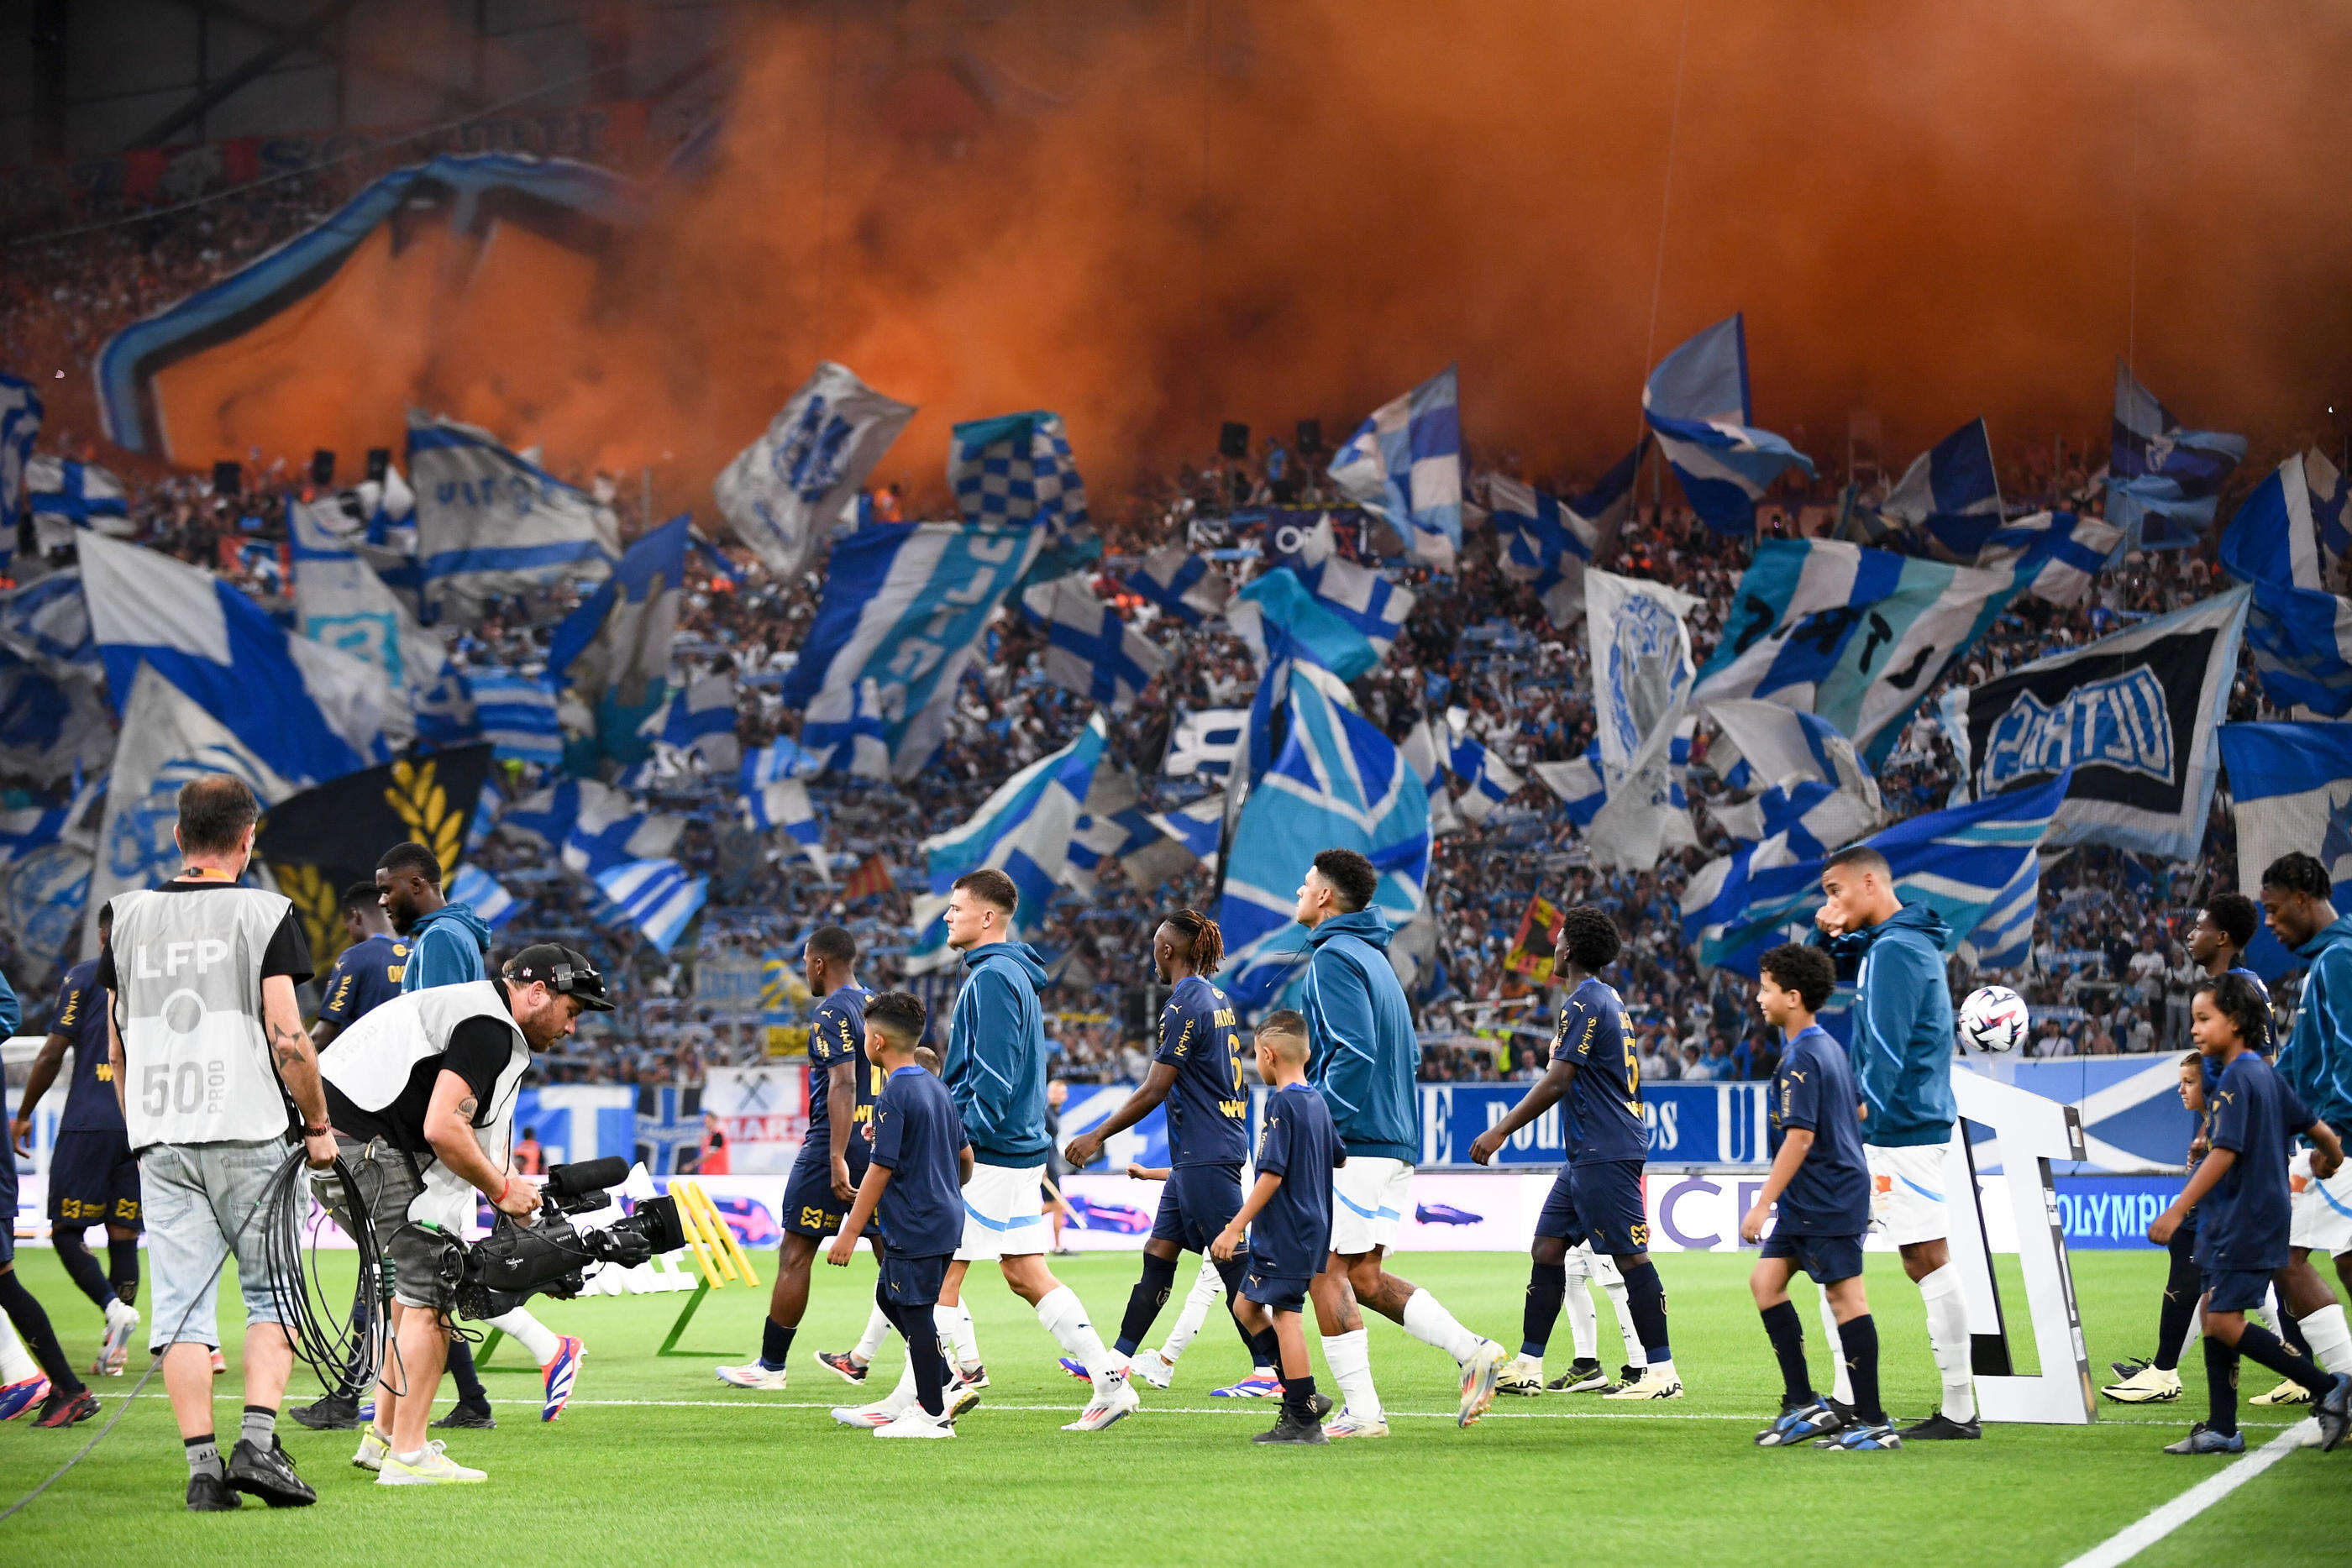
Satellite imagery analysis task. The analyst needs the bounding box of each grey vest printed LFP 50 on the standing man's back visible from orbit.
[108,882,294,1150]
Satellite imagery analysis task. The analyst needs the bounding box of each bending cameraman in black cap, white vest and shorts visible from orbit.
[320,942,612,1486]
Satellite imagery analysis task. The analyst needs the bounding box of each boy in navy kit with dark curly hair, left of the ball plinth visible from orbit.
[1740,942,1903,1453]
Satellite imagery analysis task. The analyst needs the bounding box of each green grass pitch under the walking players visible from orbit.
[0,1248,2352,1568]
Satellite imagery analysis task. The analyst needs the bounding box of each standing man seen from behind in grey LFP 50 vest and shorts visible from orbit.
[97,774,334,1514]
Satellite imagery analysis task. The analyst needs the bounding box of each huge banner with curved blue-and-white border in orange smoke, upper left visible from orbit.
[97,153,644,465]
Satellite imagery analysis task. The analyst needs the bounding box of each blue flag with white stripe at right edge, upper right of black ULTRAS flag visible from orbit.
[2220,459,2352,720]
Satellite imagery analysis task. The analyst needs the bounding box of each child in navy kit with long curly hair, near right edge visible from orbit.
[2147,976,2352,1453]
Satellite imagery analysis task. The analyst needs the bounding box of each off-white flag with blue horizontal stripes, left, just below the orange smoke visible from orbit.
[409,414,621,621]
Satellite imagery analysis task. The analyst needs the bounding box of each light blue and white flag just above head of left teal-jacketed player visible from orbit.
[900,710,1110,976]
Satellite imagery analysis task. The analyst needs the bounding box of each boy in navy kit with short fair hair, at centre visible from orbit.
[1209,1009,1347,1445]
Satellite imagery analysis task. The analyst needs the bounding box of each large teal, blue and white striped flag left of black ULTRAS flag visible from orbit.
[1693,538,2020,768]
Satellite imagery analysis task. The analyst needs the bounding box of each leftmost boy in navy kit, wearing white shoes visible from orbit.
[826,992,981,1436]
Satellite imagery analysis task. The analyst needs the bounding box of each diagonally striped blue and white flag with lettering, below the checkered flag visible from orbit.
[781,522,1044,779]
